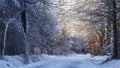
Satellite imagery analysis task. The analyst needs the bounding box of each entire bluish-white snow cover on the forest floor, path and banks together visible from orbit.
[0,54,120,68]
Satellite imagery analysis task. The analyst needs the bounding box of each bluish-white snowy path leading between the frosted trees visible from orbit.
[16,54,106,68]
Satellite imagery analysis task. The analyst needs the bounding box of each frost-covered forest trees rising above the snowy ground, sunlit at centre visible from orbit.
[0,0,120,61]
